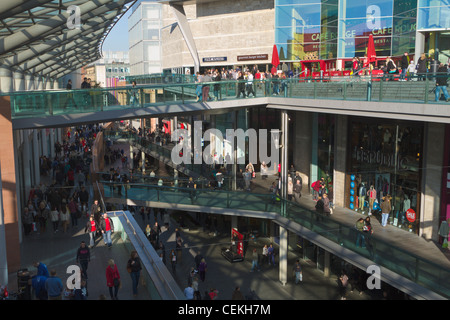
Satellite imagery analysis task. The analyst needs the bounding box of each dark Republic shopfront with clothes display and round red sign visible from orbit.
[346,117,424,233]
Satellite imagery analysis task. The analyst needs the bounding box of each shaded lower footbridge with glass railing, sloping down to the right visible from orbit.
[101,181,450,299]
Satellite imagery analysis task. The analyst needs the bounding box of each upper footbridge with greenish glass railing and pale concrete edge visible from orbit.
[5,77,450,129]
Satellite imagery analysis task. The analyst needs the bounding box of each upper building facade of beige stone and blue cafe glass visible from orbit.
[162,0,450,70]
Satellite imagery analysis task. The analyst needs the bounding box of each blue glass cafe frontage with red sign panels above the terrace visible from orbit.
[275,0,418,62]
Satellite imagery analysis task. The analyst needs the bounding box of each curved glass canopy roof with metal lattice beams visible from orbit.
[0,0,136,79]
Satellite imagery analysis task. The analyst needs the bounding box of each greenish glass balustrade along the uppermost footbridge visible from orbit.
[2,74,448,119]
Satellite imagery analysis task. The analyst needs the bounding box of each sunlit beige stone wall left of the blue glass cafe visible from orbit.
[161,0,275,68]
